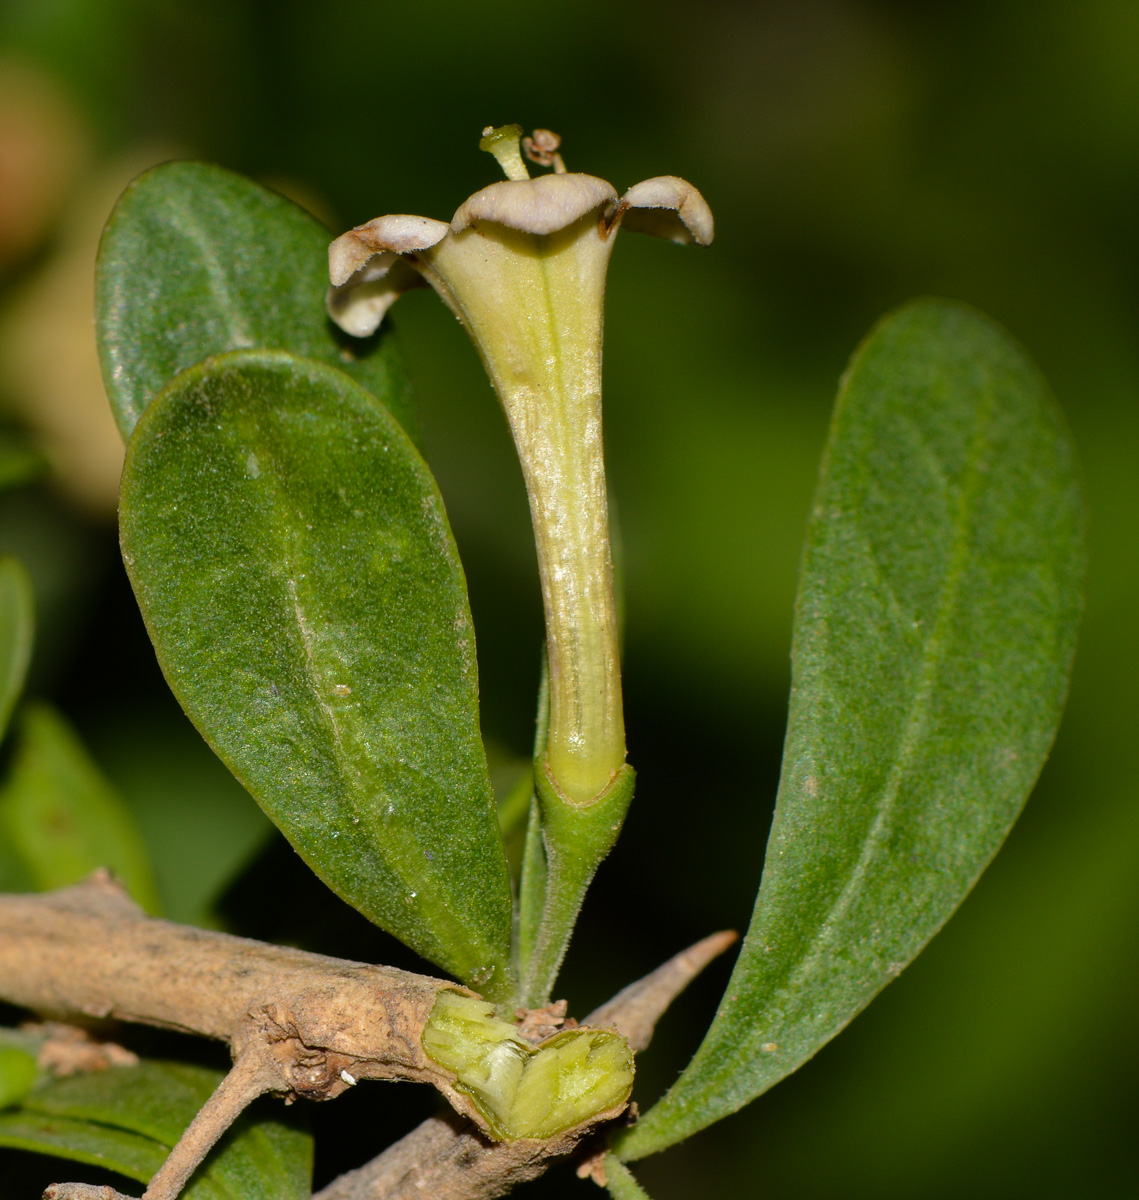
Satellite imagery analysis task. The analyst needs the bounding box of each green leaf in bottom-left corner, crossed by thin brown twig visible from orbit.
[0,1062,312,1200]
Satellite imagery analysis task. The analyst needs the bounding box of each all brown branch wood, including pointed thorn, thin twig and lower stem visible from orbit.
[0,874,735,1200]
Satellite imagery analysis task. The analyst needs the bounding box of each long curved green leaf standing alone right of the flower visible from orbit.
[618,300,1084,1160]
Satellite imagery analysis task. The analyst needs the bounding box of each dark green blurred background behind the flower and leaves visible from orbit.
[0,0,1139,1200]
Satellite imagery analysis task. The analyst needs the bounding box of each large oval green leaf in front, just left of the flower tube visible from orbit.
[120,352,511,996]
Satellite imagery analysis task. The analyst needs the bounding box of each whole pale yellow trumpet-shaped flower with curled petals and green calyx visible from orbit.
[328,126,713,1000]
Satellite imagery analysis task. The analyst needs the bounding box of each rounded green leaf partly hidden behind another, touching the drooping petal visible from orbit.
[96,162,418,438]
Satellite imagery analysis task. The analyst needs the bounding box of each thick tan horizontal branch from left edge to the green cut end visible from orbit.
[0,875,481,1122]
